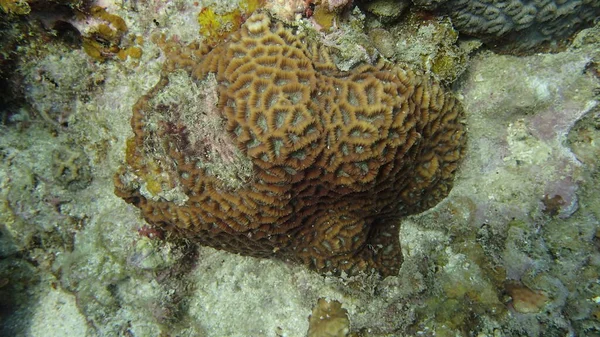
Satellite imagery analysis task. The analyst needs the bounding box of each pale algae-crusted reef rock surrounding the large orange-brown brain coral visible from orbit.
[0,0,600,337]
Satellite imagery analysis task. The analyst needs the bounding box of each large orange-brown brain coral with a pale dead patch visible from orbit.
[115,13,466,276]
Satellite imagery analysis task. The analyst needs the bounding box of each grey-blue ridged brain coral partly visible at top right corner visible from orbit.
[414,0,600,50]
